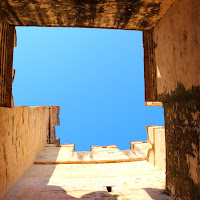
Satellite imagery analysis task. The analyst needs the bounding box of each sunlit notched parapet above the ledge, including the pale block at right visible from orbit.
[34,126,166,172]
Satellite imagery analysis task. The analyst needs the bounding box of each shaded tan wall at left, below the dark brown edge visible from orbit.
[0,107,59,199]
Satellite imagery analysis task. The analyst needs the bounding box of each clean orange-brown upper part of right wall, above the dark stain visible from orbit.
[153,0,200,95]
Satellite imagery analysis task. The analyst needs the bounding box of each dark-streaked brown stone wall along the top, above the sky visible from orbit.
[0,0,174,30]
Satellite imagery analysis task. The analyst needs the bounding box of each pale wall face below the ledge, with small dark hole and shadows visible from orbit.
[6,161,171,200]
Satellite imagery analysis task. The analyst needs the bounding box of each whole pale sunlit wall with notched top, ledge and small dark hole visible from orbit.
[1,125,167,200]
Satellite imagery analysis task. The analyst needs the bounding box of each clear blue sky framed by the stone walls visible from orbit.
[13,27,164,151]
